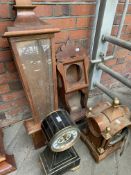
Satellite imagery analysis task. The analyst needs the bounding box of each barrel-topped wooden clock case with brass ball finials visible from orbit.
[81,98,131,162]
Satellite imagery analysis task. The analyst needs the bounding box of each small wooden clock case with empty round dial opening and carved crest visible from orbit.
[56,41,89,122]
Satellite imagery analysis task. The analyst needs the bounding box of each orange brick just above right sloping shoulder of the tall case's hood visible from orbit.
[44,18,76,29]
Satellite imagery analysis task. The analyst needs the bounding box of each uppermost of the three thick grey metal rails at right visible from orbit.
[102,35,131,50]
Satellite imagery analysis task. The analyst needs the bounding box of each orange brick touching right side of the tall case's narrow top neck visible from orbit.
[34,5,52,17]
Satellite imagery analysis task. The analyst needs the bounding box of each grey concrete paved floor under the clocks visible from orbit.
[4,88,131,175]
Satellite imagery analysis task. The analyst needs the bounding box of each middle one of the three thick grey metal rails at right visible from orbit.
[98,63,131,88]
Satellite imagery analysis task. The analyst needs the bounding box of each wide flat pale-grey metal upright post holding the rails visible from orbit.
[90,0,118,90]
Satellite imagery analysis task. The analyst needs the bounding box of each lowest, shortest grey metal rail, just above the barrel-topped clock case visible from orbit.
[94,82,116,100]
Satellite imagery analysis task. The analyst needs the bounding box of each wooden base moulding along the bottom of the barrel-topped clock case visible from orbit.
[81,133,122,162]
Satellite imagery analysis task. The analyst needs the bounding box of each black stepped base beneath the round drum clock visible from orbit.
[40,146,80,175]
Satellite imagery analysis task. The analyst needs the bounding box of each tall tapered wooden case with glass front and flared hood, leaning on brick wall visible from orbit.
[4,0,59,148]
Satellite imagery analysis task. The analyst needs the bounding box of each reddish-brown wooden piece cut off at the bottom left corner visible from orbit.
[0,128,16,175]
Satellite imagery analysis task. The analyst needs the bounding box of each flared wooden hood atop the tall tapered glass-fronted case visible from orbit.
[4,0,60,37]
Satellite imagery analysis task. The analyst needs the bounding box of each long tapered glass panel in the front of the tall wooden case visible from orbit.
[16,39,54,118]
